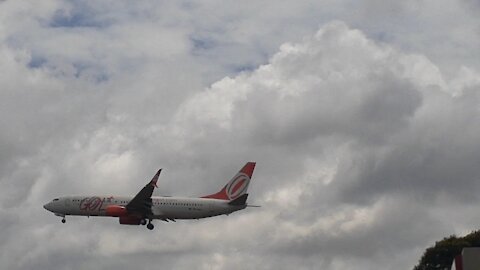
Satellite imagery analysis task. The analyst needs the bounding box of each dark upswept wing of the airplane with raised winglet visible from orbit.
[126,169,162,217]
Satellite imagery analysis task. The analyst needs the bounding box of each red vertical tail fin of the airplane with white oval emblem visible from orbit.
[202,162,255,201]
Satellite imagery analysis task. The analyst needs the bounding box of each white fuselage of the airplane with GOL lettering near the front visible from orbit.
[44,196,246,220]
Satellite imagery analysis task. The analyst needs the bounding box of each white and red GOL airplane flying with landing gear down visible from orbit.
[43,162,258,230]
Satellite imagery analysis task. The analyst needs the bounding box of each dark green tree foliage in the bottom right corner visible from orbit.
[413,231,480,270]
